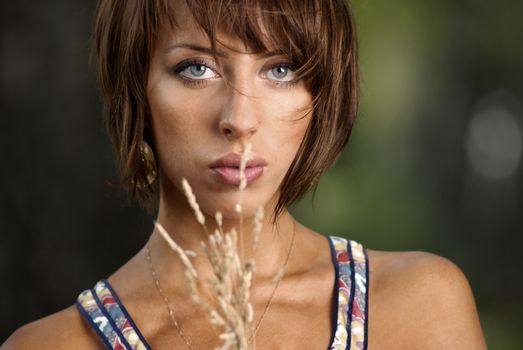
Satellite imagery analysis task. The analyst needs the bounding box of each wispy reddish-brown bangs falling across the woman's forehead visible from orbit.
[155,0,321,80]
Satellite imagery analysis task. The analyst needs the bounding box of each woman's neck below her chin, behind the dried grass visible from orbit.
[150,189,296,289]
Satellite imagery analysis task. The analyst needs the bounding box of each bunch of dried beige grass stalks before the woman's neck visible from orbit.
[155,145,263,350]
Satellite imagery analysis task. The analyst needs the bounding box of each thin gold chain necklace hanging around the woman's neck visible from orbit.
[146,221,296,350]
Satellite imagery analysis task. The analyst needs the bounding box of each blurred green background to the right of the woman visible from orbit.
[293,0,523,350]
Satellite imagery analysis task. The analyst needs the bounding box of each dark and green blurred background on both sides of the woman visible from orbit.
[0,0,523,350]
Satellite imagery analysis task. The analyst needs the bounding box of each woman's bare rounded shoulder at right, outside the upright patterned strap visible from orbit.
[368,251,486,349]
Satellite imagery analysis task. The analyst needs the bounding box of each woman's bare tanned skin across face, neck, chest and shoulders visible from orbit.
[1,1,486,350]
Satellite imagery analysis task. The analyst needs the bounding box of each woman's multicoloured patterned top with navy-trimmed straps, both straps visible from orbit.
[76,236,369,350]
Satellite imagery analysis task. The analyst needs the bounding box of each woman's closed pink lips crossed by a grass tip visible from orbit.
[210,153,267,186]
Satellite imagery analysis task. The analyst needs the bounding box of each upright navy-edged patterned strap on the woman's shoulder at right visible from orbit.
[330,236,368,350]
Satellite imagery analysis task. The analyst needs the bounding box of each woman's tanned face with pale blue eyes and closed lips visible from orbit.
[147,9,311,218]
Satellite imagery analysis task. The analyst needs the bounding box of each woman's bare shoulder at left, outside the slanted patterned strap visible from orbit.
[0,305,103,350]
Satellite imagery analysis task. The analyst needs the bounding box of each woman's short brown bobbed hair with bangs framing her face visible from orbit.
[93,0,359,215]
